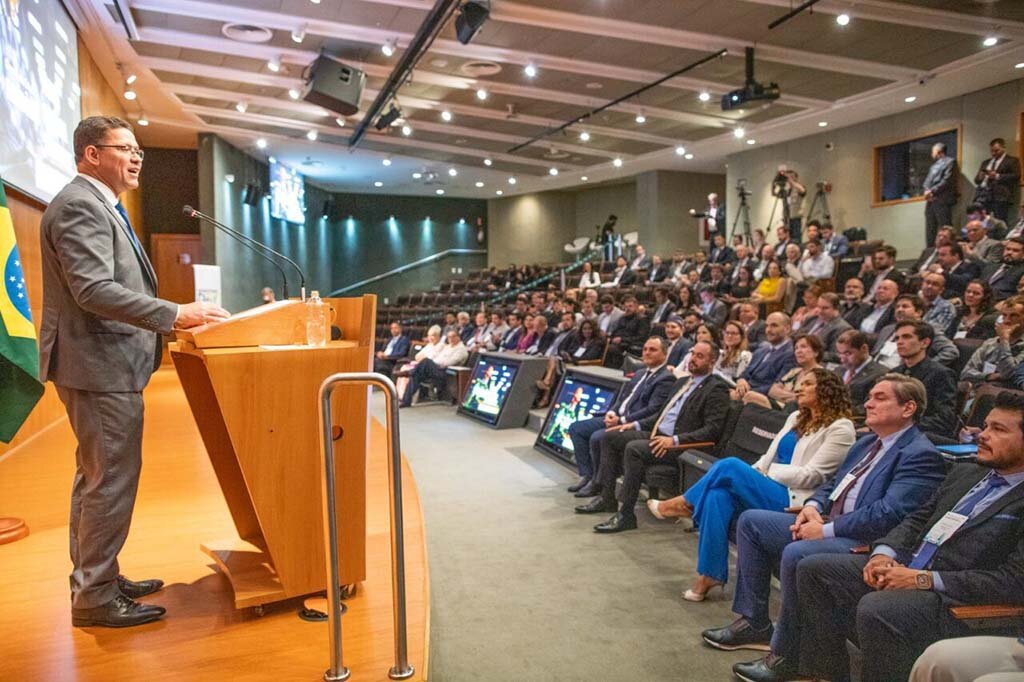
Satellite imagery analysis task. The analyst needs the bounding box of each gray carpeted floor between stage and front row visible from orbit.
[374,395,774,682]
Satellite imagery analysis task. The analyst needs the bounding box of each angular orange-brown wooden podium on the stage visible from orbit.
[170,295,377,608]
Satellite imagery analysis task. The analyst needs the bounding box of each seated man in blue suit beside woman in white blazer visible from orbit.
[703,375,945,681]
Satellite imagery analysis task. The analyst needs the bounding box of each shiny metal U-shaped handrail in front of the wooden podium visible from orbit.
[319,372,415,682]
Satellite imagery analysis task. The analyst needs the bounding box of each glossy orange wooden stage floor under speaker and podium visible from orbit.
[0,369,430,682]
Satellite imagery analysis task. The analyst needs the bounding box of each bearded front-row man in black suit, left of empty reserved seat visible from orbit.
[577,341,729,532]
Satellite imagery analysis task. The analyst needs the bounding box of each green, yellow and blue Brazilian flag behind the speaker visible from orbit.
[0,182,43,442]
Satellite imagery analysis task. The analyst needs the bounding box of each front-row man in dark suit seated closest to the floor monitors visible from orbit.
[568,336,673,491]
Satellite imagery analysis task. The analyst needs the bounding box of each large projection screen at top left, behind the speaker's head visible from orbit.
[0,0,82,201]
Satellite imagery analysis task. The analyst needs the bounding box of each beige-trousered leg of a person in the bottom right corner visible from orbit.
[909,636,1024,682]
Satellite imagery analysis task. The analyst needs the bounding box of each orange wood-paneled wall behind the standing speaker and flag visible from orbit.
[0,35,146,450]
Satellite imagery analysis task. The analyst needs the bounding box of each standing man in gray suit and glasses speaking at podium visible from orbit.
[39,117,228,627]
